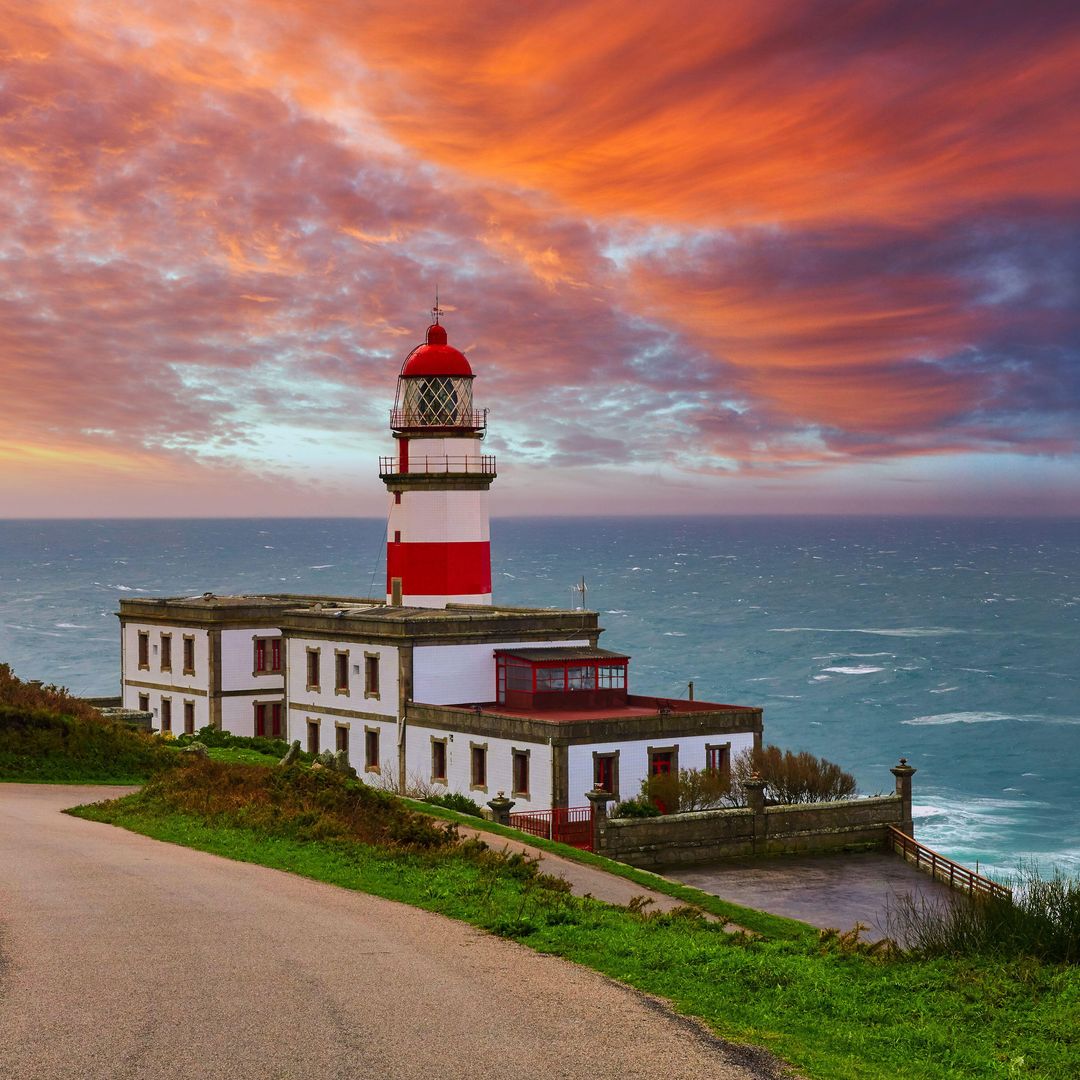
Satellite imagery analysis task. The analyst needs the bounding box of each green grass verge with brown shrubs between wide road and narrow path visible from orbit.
[75,764,1080,1080]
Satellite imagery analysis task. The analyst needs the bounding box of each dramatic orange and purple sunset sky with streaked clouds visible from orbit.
[0,0,1080,517]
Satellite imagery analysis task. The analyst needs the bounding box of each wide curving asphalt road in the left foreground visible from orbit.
[0,784,786,1080]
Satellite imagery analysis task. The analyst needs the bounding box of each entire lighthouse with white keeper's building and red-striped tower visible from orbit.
[119,312,761,810]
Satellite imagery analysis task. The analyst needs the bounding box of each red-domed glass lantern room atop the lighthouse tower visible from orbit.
[390,322,487,433]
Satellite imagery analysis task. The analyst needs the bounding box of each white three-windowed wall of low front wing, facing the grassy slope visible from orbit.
[405,726,552,811]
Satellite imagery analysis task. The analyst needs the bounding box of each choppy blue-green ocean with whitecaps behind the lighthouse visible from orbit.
[0,517,1080,875]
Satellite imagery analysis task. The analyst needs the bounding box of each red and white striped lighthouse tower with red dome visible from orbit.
[379,313,495,607]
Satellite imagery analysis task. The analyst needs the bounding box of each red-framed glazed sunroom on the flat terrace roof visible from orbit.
[495,645,630,711]
